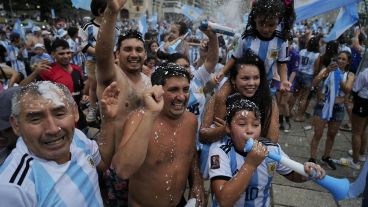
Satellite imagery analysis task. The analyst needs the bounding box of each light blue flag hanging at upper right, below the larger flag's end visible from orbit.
[324,3,359,42]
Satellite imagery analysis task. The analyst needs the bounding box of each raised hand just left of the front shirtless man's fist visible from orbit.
[100,82,120,121]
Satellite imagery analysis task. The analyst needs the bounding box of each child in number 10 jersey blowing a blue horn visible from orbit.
[209,93,325,206]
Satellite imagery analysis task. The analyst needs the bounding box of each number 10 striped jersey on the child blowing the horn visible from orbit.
[210,138,292,207]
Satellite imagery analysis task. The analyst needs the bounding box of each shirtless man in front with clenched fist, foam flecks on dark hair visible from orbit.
[113,63,203,206]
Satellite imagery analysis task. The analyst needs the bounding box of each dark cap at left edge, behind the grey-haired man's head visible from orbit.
[0,86,20,131]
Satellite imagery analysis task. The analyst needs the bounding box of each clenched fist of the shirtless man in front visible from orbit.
[143,85,164,115]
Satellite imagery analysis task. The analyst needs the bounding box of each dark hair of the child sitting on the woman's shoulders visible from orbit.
[242,0,296,40]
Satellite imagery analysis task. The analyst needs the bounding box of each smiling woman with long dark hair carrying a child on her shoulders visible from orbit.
[200,49,278,143]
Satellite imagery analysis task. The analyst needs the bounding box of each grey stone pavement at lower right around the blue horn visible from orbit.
[271,103,364,207]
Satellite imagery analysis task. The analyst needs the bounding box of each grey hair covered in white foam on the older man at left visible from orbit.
[11,81,76,120]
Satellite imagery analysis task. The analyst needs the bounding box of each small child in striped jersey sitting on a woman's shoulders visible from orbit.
[216,0,295,91]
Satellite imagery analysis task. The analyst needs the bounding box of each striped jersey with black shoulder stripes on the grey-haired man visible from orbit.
[0,129,103,207]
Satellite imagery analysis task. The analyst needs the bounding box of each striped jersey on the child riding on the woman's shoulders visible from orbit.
[232,30,289,80]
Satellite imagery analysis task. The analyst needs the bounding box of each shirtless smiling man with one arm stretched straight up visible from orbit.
[95,0,151,206]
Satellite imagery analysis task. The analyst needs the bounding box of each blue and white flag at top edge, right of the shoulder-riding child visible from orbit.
[294,0,361,22]
